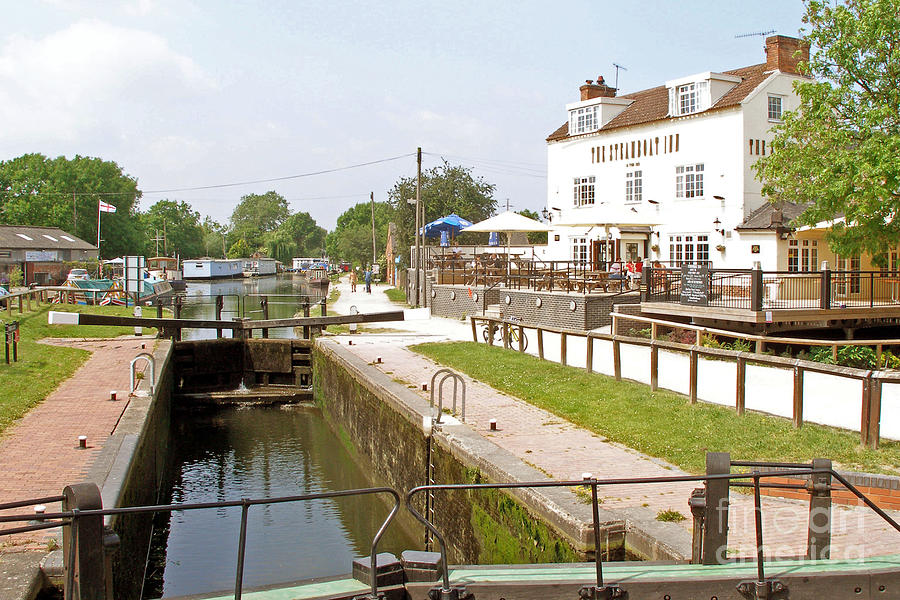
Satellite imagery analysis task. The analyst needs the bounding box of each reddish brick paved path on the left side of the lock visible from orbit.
[0,338,154,550]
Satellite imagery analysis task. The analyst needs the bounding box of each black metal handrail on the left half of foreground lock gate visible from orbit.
[0,487,400,600]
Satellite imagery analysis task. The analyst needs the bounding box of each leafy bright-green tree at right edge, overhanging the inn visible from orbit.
[755,0,900,262]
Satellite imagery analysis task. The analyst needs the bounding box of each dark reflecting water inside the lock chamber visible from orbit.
[144,405,421,598]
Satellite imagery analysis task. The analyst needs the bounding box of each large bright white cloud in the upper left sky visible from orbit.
[0,20,215,144]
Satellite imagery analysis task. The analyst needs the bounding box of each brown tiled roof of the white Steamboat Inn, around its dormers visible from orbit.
[547,63,771,142]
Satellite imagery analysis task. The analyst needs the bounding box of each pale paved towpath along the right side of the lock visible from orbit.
[334,282,900,558]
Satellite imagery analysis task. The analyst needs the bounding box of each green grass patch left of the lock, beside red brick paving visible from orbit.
[0,305,156,433]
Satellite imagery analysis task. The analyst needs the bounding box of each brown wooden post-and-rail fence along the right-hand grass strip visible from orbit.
[469,313,900,449]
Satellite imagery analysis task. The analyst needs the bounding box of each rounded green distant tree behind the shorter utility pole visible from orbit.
[325,202,393,265]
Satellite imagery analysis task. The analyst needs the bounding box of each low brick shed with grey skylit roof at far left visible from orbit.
[0,225,98,285]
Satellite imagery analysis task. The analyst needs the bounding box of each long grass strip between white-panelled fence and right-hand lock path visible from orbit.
[412,342,900,474]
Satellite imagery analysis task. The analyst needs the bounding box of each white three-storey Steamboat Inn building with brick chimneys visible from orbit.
[547,36,816,270]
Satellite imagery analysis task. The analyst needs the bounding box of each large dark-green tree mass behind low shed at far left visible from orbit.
[0,154,143,258]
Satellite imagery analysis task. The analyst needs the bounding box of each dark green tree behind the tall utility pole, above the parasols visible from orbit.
[388,161,497,256]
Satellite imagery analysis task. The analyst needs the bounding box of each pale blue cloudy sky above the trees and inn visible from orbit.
[0,0,804,229]
